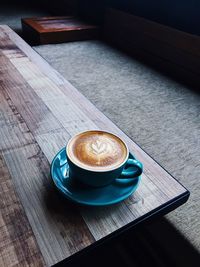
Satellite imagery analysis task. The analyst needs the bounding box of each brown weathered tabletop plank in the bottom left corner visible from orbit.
[0,153,44,267]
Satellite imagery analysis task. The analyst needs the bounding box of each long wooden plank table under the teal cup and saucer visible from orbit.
[0,26,189,267]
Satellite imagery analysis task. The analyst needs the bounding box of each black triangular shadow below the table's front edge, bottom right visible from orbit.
[56,218,200,267]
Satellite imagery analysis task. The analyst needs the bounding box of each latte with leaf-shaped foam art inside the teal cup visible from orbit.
[67,131,128,171]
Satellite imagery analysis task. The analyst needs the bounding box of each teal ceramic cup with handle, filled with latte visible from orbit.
[66,130,143,187]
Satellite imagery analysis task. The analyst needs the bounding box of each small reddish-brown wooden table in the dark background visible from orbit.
[21,16,99,45]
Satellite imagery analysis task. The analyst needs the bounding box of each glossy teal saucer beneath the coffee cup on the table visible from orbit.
[51,148,140,206]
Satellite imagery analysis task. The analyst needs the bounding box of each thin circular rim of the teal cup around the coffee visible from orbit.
[65,130,129,172]
